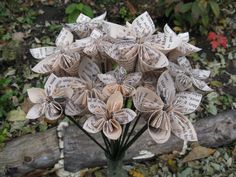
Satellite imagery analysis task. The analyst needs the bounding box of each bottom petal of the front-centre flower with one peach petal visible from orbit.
[103,119,122,140]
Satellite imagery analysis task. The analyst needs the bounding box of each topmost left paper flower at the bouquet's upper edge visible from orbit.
[66,12,107,38]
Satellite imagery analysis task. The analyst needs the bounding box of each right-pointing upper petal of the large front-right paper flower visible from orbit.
[173,92,202,114]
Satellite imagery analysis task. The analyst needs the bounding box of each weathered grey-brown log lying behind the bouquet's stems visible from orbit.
[0,110,236,177]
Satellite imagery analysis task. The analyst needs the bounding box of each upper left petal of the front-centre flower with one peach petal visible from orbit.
[88,98,107,115]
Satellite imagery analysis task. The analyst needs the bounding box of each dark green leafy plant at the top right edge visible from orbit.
[157,0,220,34]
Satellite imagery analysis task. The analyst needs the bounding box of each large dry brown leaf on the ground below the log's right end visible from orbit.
[183,146,216,163]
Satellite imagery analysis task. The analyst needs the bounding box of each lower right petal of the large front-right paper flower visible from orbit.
[170,113,197,141]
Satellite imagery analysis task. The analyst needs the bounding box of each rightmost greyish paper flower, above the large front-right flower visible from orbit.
[169,57,212,91]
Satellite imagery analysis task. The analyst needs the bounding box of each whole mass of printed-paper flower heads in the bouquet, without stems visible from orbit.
[27,12,212,143]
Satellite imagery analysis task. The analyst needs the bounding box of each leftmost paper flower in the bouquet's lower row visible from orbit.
[26,74,73,120]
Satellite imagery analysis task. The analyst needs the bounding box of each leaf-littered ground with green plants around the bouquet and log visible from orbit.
[0,0,236,177]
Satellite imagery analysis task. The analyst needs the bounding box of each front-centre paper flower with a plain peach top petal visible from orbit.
[83,92,136,140]
